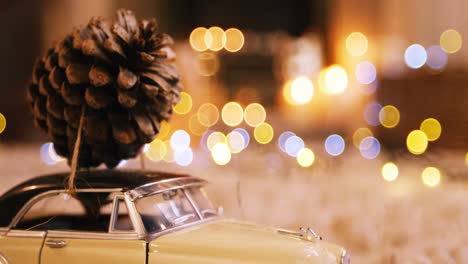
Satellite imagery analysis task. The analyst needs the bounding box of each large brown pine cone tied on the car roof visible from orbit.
[28,10,181,168]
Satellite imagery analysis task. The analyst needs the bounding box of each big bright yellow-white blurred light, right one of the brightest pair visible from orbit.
[319,64,348,94]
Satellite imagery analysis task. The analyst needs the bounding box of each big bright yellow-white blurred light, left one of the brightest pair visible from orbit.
[283,76,314,105]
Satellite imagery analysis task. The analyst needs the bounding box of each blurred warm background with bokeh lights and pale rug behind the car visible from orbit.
[0,0,468,263]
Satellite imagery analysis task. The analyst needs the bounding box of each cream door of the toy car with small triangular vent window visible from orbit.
[41,192,146,264]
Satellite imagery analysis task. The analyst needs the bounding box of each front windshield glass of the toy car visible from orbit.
[135,189,200,233]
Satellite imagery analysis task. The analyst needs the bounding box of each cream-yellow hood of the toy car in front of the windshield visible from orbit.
[149,220,343,264]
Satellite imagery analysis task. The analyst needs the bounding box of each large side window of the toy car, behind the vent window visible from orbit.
[14,193,112,232]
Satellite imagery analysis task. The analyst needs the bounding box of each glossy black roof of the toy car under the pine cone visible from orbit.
[0,170,192,227]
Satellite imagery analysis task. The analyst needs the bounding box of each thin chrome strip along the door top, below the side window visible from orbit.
[47,230,139,240]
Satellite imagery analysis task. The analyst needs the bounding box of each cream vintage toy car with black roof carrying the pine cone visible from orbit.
[0,170,350,264]
